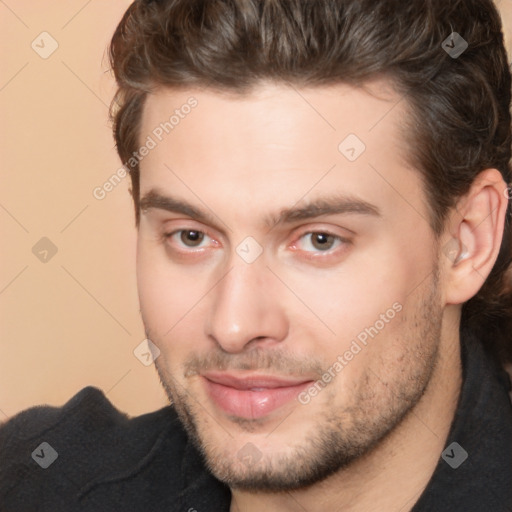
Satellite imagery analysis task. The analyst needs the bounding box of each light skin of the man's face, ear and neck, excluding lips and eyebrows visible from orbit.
[137,82,506,512]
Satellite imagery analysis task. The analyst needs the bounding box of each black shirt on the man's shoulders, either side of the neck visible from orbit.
[0,334,512,512]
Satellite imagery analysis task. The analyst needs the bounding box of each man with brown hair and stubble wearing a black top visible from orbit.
[0,0,512,512]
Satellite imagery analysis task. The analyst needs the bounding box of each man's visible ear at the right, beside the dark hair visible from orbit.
[440,169,509,304]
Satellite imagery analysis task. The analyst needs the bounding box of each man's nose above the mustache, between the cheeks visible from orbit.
[206,258,289,353]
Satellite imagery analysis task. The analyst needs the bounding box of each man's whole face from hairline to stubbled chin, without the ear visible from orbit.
[137,84,442,489]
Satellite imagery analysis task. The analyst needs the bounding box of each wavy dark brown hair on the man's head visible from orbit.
[110,0,512,362]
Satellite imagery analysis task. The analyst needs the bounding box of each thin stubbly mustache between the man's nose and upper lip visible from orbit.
[183,348,325,378]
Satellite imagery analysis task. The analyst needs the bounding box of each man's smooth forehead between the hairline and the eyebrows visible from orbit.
[136,81,421,228]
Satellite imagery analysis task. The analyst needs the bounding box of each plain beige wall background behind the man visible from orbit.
[0,0,512,422]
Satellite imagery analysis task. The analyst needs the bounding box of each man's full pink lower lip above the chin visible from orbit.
[203,378,311,419]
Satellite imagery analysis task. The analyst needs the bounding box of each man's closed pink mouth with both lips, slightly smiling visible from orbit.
[201,372,314,419]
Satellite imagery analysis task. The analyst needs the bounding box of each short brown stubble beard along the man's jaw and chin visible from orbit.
[150,273,442,492]
